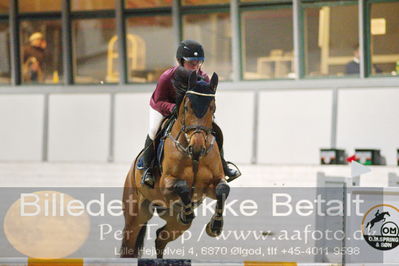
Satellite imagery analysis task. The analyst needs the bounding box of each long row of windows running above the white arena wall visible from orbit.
[0,0,399,87]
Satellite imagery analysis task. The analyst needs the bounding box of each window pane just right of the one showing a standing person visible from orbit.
[72,18,118,84]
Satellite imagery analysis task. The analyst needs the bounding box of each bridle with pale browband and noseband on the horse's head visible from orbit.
[168,90,216,160]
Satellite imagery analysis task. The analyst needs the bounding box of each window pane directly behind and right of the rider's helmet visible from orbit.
[183,12,232,80]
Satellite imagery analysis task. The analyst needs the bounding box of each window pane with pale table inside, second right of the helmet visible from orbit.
[241,8,295,79]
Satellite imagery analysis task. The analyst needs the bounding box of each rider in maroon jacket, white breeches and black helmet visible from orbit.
[141,40,241,188]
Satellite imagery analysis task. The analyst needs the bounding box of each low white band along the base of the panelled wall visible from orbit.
[0,162,399,188]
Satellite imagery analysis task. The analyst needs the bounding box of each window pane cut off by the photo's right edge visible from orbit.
[370,2,399,75]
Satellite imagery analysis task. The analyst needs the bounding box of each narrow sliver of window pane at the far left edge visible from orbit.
[0,22,11,83]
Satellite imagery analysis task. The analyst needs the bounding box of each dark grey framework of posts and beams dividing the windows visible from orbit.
[0,0,399,86]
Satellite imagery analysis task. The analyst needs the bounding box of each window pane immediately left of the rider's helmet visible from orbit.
[126,16,176,82]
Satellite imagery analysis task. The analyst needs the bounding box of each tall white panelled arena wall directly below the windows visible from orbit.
[0,85,399,165]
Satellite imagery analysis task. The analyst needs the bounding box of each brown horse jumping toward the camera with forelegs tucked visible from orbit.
[121,69,230,258]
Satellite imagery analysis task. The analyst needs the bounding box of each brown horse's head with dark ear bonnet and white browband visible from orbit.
[173,68,218,160]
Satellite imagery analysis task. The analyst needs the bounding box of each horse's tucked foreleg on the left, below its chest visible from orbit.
[173,180,195,225]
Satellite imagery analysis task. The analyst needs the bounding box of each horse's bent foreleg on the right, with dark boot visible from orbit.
[206,179,230,237]
